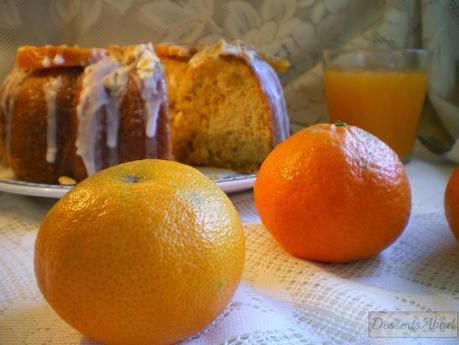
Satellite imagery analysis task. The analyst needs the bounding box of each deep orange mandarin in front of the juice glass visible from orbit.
[254,123,411,262]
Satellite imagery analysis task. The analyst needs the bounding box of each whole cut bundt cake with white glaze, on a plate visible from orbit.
[0,41,289,183]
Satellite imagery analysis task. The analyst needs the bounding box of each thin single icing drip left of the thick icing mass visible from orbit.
[43,77,62,163]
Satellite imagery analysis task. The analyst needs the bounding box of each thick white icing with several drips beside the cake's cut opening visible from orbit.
[76,44,167,175]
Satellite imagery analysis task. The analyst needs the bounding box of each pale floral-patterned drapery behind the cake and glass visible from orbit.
[0,0,459,162]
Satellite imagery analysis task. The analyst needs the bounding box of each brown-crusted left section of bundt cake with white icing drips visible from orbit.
[0,44,171,183]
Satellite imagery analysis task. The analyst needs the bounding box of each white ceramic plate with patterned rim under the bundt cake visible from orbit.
[0,168,255,199]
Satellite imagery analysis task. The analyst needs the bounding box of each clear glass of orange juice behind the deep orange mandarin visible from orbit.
[323,48,430,162]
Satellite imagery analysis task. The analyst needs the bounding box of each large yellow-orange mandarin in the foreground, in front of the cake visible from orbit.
[35,160,245,345]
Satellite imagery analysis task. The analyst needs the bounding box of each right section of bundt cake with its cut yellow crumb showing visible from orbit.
[156,40,289,172]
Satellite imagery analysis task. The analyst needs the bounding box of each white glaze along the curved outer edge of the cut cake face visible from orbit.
[189,40,290,146]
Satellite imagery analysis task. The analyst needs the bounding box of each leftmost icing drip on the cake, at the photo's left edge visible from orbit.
[0,68,29,160]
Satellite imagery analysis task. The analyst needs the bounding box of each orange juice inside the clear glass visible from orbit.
[325,69,427,159]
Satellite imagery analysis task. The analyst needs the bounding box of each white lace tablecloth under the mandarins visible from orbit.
[0,154,459,345]
